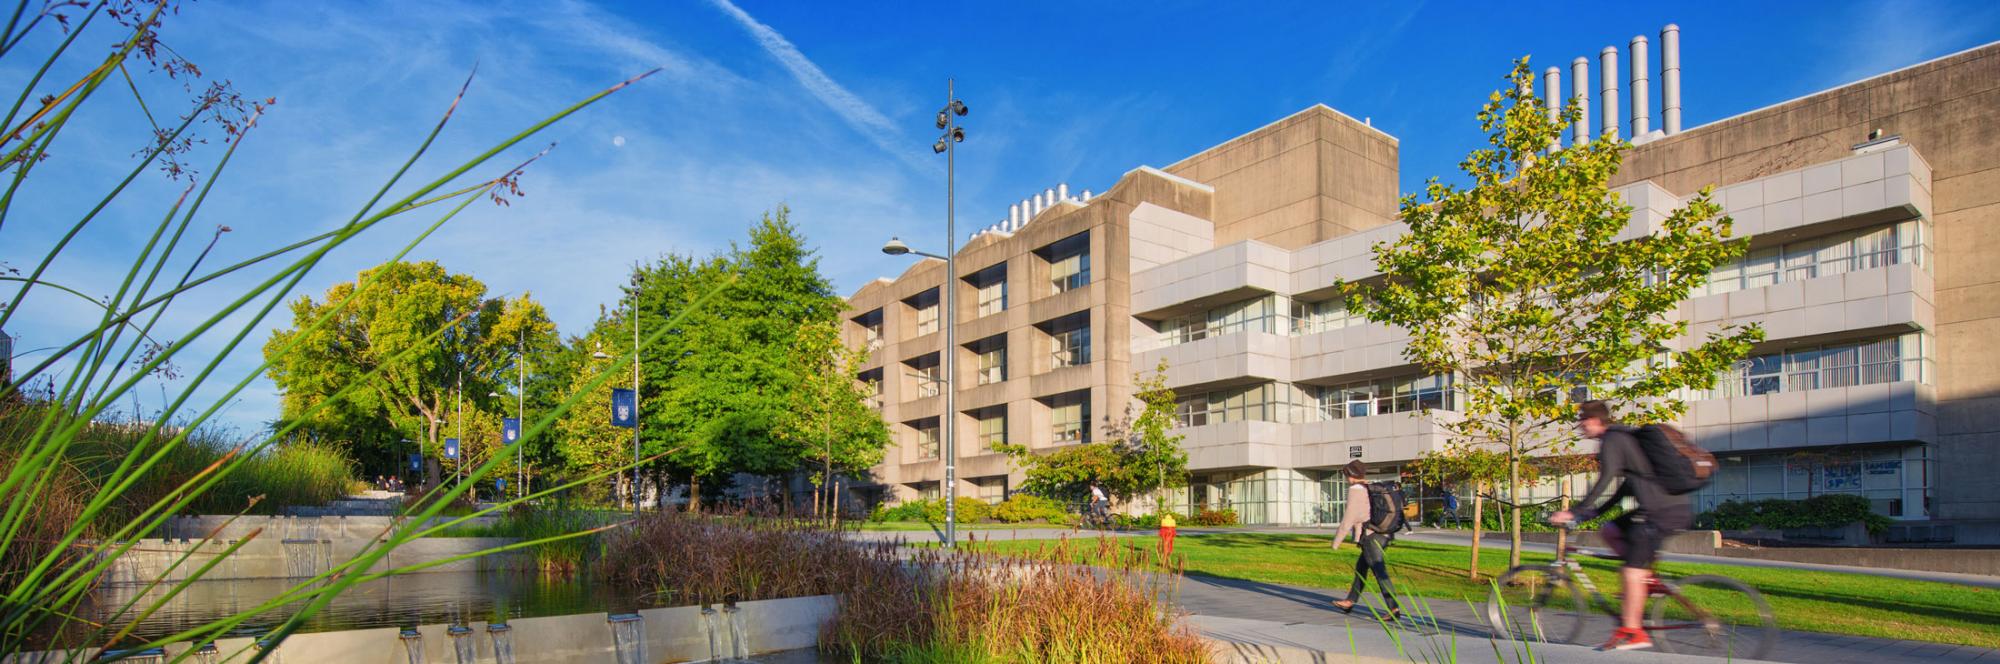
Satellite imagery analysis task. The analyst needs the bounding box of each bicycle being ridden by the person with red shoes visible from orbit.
[1486,496,1778,660]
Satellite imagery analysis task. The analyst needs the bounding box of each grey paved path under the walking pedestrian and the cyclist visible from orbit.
[1174,576,2000,664]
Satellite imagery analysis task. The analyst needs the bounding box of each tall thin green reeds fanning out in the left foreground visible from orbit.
[0,0,704,660]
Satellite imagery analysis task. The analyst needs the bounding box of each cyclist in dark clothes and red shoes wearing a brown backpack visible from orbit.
[1548,400,1694,650]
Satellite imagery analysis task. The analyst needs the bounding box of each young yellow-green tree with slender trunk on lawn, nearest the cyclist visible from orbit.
[1342,58,1762,564]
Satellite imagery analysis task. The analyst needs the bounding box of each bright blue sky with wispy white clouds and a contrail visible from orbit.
[0,0,2000,428]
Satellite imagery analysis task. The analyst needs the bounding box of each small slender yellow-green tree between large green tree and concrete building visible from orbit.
[780,322,890,514]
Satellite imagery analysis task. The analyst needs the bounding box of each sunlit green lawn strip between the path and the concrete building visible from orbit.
[956,532,2000,648]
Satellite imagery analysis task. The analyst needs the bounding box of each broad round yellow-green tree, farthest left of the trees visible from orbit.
[264,262,556,488]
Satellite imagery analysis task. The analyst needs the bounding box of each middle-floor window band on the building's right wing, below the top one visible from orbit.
[1706,332,1932,398]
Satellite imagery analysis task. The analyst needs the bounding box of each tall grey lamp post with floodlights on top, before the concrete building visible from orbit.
[882,78,966,548]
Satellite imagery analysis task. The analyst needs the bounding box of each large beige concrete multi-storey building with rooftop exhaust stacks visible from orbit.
[848,26,2000,542]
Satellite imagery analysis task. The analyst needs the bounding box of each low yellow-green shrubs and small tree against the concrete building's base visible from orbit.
[994,360,1188,508]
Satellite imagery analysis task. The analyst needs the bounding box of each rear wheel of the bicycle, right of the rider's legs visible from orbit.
[1646,574,1778,660]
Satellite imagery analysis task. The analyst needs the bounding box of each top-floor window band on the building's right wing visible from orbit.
[1694,220,1930,296]
